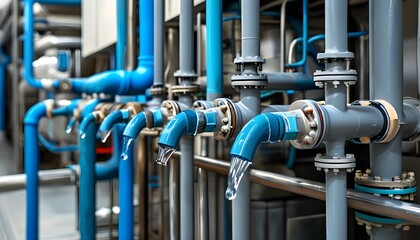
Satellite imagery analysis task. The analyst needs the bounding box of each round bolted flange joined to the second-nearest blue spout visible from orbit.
[214,98,238,141]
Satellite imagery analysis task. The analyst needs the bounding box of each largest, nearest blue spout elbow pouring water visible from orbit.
[230,112,299,162]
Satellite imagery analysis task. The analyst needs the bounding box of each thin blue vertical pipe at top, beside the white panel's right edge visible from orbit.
[115,0,127,70]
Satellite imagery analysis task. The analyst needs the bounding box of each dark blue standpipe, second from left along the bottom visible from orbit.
[79,114,97,239]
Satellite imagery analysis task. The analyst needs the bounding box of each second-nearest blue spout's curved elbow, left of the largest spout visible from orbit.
[159,110,199,148]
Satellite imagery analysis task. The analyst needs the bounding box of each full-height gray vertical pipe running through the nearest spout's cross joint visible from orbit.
[325,0,349,239]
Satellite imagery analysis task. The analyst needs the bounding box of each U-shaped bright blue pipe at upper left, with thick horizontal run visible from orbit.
[24,0,153,95]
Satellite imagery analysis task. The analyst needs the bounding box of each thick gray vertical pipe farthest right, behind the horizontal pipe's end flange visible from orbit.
[369,0,404,240]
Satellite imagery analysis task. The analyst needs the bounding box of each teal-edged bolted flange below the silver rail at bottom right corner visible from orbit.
[355,211,412,234]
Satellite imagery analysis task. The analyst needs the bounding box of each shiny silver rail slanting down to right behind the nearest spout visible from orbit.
[174,152,420,225]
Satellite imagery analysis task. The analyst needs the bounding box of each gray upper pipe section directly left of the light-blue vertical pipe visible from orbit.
[179,0,194,73]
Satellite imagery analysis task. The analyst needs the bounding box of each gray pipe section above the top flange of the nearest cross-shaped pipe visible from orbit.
[325,0,347,53]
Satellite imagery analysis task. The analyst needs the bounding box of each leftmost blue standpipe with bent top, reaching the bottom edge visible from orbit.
[23,102,47,240]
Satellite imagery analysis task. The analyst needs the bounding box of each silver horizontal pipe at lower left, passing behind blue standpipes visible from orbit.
[0,168,77,193]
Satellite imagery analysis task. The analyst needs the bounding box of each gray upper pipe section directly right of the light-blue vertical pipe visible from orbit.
[241,0,260,58]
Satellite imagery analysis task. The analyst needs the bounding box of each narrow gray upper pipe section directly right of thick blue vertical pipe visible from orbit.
[153,0,165,85]
